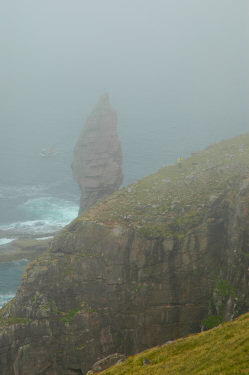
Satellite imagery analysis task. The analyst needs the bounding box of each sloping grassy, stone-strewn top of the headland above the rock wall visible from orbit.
[75,133,249,239]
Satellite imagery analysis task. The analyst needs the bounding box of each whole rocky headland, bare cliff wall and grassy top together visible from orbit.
[0,135,249,375]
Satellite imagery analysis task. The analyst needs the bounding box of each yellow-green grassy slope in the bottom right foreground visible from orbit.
[98,314,249,375]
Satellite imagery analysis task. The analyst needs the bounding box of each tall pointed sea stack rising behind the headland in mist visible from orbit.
[72,94,123,214]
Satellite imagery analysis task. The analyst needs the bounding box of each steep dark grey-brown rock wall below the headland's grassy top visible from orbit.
[0,190,249,375]
